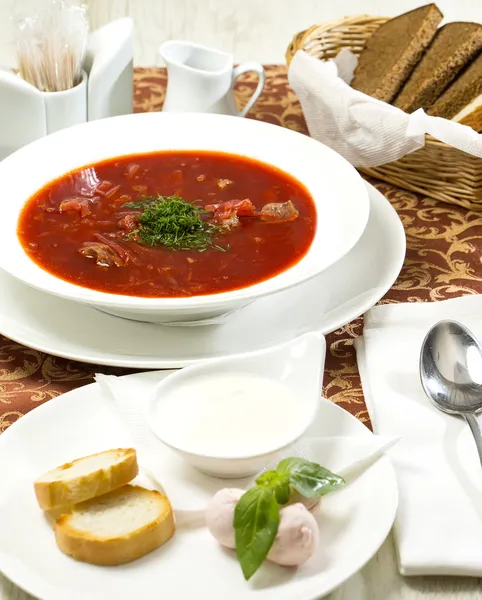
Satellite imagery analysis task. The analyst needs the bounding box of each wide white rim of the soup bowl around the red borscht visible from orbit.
[0,113,370,312]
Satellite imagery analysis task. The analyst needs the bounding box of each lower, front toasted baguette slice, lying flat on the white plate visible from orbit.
[54,485,175,566]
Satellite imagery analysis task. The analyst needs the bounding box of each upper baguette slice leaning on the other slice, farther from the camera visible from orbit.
[34,448,139,510]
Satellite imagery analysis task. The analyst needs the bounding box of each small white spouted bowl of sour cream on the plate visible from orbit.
[146,332,326,478]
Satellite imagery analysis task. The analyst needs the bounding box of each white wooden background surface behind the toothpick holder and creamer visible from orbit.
[0,0,482,66]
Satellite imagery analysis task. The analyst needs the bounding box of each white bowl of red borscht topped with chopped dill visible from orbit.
[0,113,369,322]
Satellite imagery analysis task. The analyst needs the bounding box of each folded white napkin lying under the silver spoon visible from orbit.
[355,296,482,577]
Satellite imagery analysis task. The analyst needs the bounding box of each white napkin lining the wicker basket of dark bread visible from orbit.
[288,51,482,167]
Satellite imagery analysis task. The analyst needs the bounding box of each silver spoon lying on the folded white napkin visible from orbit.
[420,321,482,465]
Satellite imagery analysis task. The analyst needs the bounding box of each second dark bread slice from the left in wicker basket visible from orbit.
[394,23,482,113]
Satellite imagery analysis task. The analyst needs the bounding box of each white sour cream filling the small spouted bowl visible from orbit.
[157,372,306,458]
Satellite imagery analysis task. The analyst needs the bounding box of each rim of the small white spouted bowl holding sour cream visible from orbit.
[146,331,326,461]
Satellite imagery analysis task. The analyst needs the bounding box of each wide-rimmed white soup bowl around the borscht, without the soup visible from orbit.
[0,113,369,321]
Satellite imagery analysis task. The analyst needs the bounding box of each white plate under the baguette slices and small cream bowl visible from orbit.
[0,373,398,600]
